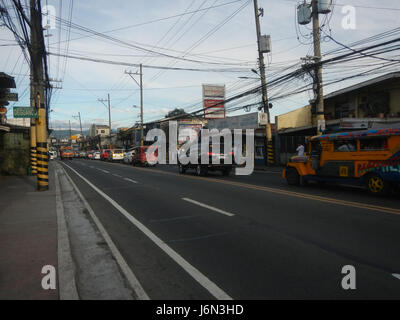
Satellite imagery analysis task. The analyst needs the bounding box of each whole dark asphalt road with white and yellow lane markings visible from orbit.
[57,159,400,299]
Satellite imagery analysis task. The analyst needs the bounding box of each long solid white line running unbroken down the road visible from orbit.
[61,165,233,300]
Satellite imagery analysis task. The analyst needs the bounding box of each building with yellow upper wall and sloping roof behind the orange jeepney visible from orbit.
[275,72,400,164]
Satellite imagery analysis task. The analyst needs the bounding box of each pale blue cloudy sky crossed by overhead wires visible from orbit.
[0,0,400,129]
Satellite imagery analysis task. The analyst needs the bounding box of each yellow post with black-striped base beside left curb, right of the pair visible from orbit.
[36,94,49,191]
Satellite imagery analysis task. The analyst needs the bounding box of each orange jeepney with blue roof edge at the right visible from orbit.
[282,128,400,194]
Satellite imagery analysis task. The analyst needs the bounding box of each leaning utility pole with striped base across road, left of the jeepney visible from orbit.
[253,0,274,165]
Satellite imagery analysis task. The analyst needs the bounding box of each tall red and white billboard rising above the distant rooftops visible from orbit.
[203,84,225,119]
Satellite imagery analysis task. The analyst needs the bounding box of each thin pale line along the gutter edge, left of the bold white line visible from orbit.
[63,165,150,300]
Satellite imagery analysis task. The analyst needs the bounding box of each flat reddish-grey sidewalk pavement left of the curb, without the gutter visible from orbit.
[0,166,59,300]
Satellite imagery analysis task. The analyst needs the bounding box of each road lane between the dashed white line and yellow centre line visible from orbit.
[76,159,400,272]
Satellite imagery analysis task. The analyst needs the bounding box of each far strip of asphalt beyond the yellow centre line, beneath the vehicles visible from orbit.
[140,165,400,208]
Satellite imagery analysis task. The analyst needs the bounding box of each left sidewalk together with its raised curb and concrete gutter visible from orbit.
[0,162,136,300]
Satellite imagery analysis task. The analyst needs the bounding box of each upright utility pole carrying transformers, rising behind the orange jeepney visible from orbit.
[311,0,325,135]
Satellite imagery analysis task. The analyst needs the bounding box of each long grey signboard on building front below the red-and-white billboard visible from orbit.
[208,112,264,130]
